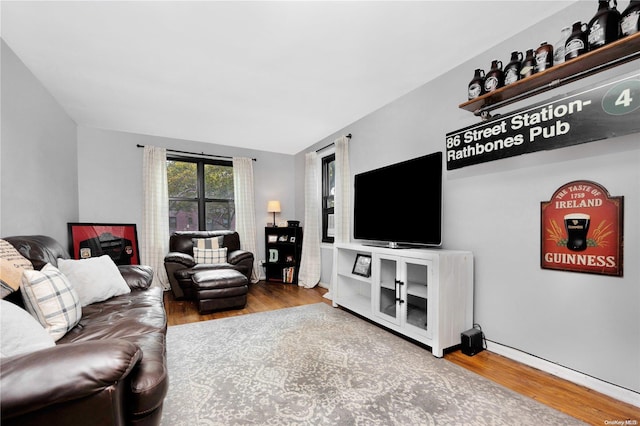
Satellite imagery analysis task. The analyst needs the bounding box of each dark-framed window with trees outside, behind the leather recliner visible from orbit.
[167,157,235,233]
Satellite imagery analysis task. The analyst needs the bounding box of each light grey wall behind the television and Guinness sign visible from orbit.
[296,2,640,399]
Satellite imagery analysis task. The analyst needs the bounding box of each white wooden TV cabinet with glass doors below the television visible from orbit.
[333,243,473,357]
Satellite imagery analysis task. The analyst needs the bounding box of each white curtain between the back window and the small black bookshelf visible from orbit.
[233,158,259,283]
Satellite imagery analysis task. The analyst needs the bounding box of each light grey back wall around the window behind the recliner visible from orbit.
[78,126,296,259]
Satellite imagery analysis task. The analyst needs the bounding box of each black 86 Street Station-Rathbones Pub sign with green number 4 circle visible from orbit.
[446,73,640,170]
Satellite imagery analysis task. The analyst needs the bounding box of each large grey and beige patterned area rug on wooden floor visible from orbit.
[162,303,582,426]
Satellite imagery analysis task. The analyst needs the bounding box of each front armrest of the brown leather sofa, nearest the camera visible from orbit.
[0,339,142,421]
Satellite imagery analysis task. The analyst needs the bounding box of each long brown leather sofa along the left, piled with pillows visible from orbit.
[0,235,169,426]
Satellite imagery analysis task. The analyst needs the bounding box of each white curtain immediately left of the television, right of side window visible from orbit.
[324,136,351,300]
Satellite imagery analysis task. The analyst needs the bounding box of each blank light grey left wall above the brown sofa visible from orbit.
[0,40,78,246]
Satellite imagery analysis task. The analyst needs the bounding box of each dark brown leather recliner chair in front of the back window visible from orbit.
[164,231,254,300]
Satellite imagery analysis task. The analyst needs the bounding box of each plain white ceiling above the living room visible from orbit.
[1,0,575,154]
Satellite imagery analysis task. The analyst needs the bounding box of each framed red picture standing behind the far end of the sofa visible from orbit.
[67,223,140,265]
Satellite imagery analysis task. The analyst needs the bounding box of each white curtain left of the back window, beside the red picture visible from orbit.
[140,146,170,290]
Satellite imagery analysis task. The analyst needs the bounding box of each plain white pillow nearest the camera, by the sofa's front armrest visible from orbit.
[0,300,56,357]
